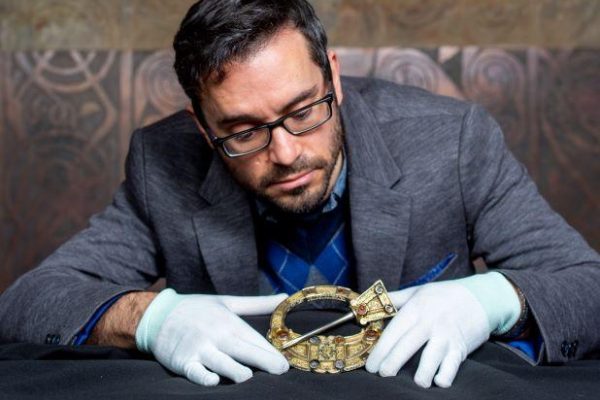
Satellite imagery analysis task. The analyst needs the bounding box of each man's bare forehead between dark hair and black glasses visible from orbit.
[202,29,323,117]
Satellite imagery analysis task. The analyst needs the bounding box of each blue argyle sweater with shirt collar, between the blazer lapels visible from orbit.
[257,161,354,294]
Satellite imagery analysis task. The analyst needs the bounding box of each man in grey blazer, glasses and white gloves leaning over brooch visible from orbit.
[0,0,600,387]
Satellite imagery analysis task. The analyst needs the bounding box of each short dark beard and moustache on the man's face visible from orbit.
[252,109,344,214]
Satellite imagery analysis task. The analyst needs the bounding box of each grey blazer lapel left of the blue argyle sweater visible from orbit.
[193,156,258,295]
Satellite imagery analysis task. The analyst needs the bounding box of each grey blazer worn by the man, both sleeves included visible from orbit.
[0,78,600,362]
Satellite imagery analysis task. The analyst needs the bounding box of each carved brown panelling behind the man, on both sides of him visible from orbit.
[0,47,600,290]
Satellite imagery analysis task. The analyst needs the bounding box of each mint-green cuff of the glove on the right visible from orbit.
[456,272,521,335]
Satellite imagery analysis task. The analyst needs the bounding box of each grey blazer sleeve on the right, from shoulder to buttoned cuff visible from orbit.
[459,106,600,363]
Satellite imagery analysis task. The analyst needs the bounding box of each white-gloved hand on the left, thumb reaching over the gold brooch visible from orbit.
[135,289,289,386]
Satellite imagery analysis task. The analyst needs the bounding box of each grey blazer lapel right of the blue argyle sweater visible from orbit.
[341,88,411,291]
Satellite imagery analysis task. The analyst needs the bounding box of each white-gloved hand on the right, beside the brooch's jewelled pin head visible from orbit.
[365,272,521,388]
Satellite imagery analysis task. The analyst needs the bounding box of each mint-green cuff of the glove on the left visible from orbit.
[135,289,182,353]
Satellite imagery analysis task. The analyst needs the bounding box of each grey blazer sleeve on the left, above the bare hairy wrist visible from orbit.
[0,132,160,344]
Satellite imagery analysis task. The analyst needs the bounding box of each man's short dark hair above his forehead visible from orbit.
[173,0,331,127]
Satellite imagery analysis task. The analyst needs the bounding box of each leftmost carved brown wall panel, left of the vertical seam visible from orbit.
[0,50,121,287]
